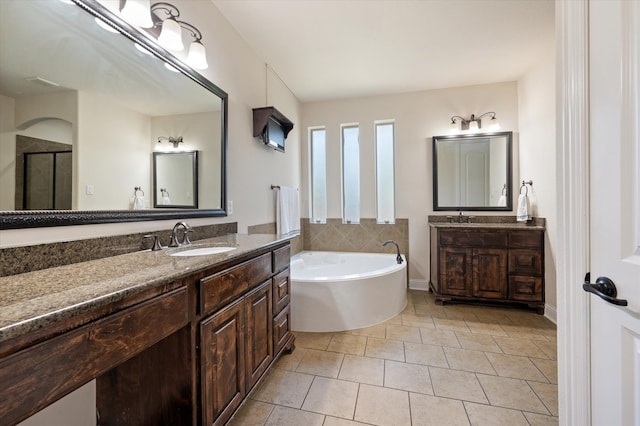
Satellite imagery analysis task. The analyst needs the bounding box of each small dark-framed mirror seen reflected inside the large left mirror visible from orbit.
[153,151,198,209]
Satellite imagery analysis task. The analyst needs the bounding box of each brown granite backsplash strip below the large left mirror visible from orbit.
[0,222,238,277]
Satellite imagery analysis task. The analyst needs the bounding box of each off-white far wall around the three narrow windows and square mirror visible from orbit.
[301,82,519,288]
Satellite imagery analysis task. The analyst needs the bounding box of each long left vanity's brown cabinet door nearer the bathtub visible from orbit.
[245,280,273,391]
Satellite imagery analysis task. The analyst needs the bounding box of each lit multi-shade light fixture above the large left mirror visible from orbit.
[120,0,209,70]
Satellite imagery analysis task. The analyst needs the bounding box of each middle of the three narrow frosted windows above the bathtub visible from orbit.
[341,125,360,223]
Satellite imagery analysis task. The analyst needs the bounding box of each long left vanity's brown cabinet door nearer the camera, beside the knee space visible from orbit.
[200,299,246,425]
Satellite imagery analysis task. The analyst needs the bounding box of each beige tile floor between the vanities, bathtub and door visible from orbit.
[230,290,558,426]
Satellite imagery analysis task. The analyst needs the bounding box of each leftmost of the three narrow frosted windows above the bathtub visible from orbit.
[309,127,327,223]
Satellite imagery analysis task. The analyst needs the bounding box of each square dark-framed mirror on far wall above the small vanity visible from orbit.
[433,132,513,211]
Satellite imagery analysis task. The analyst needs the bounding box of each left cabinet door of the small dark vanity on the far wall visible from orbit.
[440,247,473,296]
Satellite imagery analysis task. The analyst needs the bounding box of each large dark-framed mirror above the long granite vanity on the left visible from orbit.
[0,0,228,229]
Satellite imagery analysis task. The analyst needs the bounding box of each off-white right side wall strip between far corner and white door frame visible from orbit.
[518,45,558,321]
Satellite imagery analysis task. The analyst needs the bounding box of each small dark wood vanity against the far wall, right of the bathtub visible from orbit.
[429,216,545,314]
